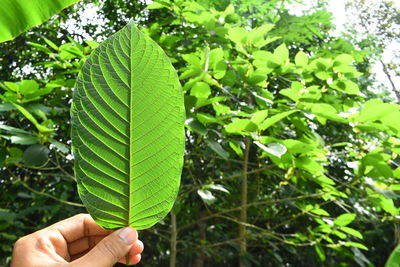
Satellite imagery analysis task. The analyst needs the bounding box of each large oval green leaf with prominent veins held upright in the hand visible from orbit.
[71,23,185,229]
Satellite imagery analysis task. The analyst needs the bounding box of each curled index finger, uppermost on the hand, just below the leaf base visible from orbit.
[51,214,112,243]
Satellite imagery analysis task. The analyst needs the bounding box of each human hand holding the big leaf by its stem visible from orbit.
[11,214,143,267]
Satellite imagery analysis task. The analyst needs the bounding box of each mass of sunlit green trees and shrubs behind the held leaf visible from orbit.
[0,0,400,267]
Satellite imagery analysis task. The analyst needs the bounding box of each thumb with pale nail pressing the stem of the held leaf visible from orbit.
[78,227,138,267]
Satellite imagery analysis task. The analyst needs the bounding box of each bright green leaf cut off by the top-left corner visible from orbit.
[0,0,80,43]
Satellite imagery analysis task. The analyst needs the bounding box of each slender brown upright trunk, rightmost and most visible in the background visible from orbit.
[239,137,250,267]
